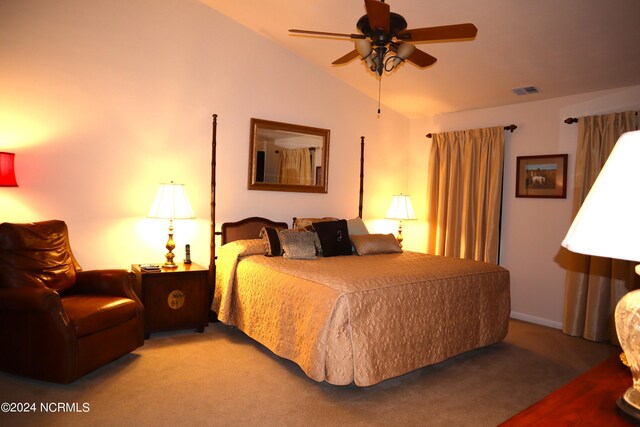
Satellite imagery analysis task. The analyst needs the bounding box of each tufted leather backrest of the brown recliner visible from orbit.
[0,220,79,292]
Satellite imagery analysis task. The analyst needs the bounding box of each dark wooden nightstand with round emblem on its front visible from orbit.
[131,263,209,338]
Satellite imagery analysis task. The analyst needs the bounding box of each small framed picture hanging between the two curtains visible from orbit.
[516,154,569,199]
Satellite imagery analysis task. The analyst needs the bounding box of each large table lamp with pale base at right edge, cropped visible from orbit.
[562,131,640,419]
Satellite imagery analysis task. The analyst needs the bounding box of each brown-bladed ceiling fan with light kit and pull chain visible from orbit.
[289,0,478,76]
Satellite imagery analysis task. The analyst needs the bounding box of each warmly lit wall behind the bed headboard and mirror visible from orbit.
[0,0,409,269]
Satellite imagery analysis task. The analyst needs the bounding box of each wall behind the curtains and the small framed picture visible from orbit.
[406,86,640,328]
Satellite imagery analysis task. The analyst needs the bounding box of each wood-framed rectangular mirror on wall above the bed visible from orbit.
[248,119,330,193]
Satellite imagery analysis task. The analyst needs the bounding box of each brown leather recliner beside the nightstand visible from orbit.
[0,220,144,383]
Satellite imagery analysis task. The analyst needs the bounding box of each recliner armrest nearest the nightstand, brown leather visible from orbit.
[71,270,138,301]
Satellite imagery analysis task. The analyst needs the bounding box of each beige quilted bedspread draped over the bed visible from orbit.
[212,242,510,386]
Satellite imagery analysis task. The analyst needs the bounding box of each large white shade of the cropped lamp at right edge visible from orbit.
[562,131,640,261]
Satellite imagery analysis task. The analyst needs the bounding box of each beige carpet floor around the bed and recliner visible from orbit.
[0,321,618,426]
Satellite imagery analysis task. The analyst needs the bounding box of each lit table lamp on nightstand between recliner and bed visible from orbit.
[147,181,195,268]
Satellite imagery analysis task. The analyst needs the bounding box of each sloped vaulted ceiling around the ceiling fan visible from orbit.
[201,0,640,118]
